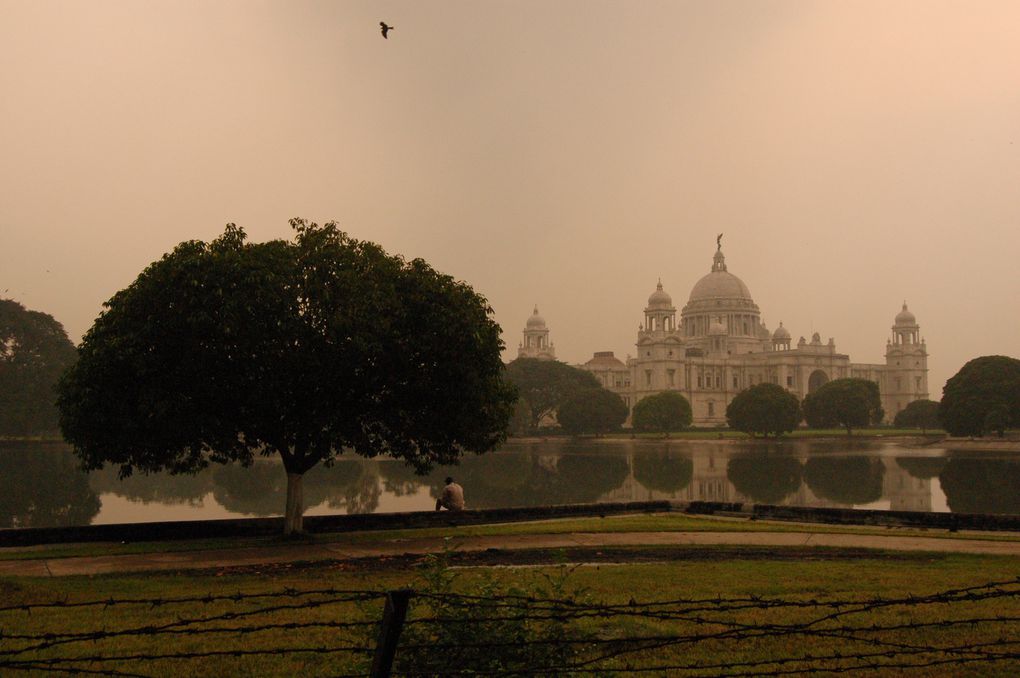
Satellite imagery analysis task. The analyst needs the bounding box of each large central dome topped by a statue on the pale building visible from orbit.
[680,237,762,354]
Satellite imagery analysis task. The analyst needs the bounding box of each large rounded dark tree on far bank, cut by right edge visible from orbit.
[938,356,1020,435]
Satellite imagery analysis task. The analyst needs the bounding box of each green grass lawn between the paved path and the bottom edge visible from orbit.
[0,547,1020,676]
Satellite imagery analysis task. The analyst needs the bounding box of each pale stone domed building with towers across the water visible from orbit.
[571,245,928,426]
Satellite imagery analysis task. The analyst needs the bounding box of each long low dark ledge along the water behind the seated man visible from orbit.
[0,502,670,546]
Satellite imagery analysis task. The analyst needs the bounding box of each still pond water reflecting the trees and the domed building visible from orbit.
[0,439,1020,527]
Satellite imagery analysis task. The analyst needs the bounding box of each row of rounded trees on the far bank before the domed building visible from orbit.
[507,356,1020,437]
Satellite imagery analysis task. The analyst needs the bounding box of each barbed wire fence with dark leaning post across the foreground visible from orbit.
[0,578,1020,677]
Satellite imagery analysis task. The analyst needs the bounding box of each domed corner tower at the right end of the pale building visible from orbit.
[882,302,928,421]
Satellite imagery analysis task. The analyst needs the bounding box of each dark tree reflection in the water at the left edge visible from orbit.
[0,441,100,527]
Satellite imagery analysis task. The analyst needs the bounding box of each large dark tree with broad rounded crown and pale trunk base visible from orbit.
[59,219,515,533]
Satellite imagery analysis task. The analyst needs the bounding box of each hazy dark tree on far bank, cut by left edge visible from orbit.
[0,299,74,435]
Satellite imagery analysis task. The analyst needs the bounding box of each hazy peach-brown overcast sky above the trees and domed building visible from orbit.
[0,0,1020,393]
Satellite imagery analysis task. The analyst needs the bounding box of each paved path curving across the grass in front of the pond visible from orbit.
[0,532,1020,576]
